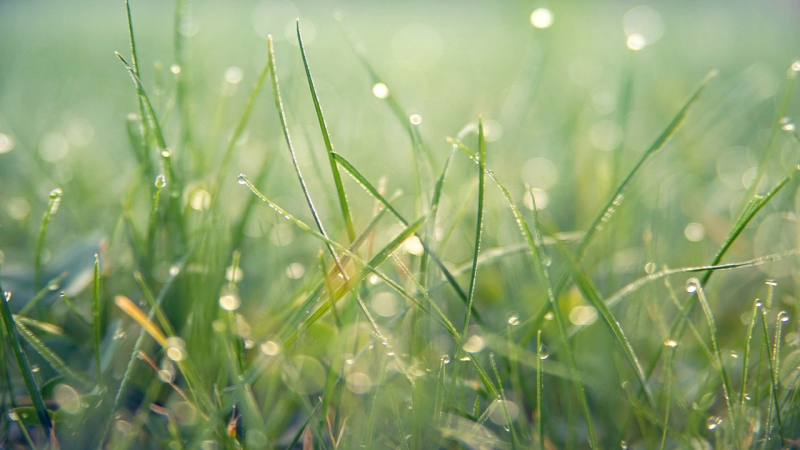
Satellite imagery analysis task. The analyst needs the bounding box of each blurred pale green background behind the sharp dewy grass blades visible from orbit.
[0,0,800,446]
